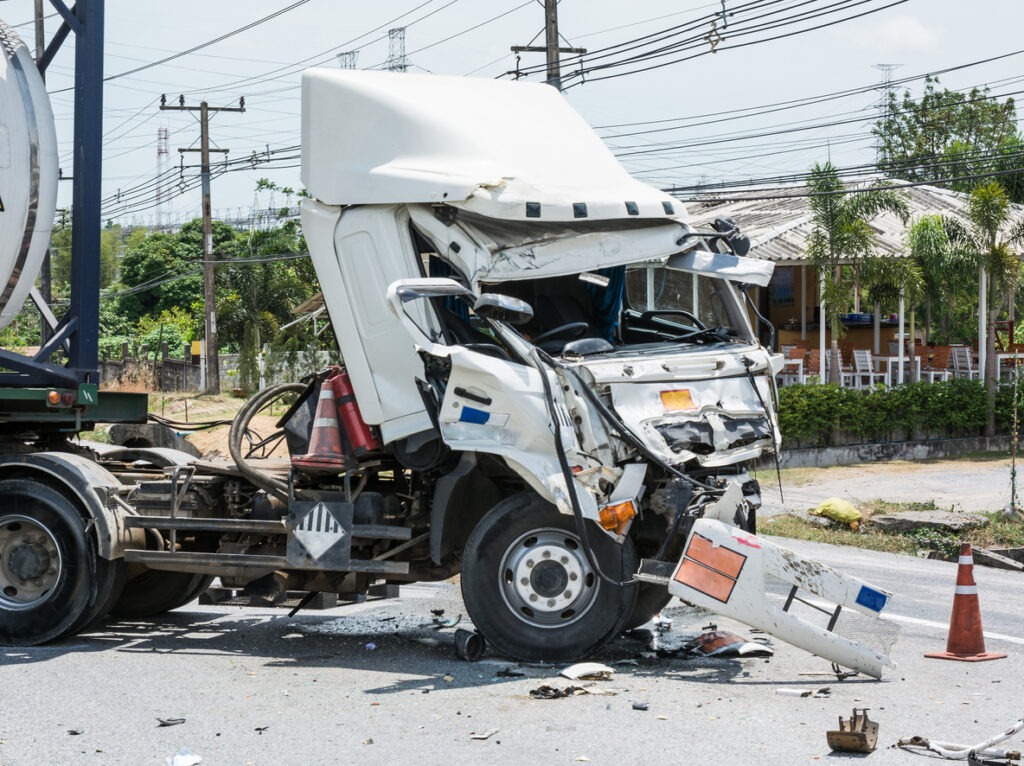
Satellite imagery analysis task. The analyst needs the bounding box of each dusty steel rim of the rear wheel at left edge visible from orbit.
[0,514,63,611]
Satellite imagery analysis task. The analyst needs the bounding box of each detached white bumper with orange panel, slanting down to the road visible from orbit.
[659,518,898,678]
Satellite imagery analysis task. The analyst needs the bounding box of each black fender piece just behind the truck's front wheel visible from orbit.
[430,453,501,565]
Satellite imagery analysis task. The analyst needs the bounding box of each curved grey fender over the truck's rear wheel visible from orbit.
[0,452,131,559]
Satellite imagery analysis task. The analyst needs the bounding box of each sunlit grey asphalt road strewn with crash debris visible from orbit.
[0,541,1024,766]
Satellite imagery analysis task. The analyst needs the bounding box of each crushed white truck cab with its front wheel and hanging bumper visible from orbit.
[294,71,887,675]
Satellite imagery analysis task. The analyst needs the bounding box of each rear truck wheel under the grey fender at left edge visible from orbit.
[0,478,103,646]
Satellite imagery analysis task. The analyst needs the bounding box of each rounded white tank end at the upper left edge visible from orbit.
[0,22,58,329]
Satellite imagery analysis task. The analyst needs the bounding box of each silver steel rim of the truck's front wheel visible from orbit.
[499,527,599,628]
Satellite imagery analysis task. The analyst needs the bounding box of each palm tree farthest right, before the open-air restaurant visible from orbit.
[943,180,1024,436]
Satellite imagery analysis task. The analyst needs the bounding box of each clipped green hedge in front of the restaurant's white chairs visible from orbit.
[778,379,1024,446]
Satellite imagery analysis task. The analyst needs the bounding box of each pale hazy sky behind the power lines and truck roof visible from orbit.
[0,0,1024,225]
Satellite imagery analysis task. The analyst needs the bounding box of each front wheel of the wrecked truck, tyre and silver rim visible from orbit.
[462,493,637,663]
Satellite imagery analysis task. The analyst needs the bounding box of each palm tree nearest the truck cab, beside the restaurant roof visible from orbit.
[807,162,909,383]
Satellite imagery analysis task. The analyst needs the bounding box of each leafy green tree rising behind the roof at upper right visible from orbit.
[871,77,1024,201]
